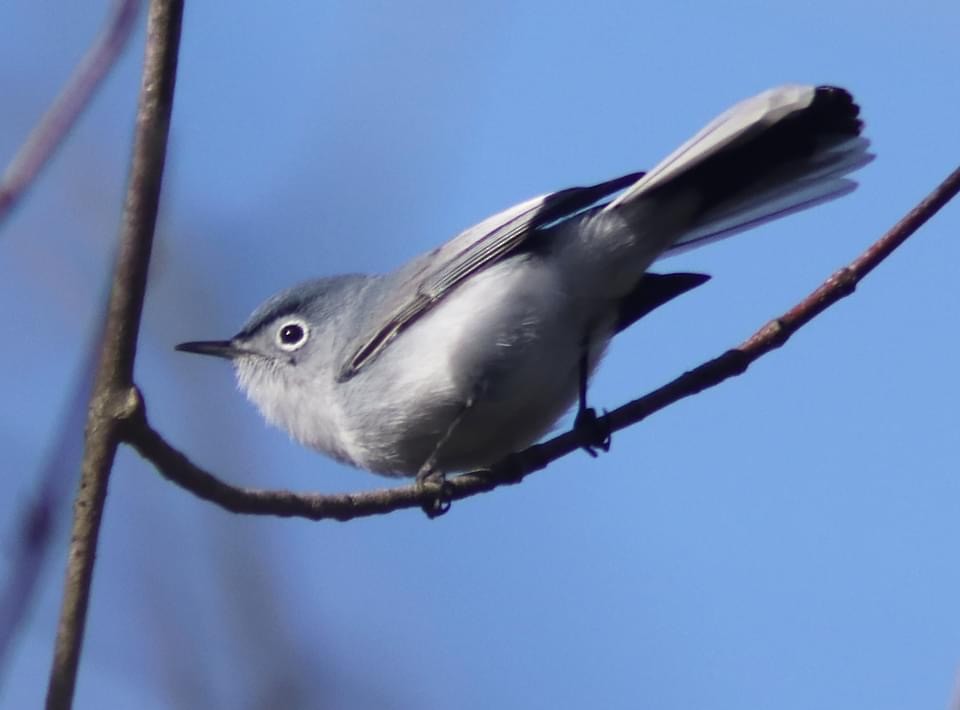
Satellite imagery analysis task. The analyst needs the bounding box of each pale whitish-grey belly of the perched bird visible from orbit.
[345,257,605,475]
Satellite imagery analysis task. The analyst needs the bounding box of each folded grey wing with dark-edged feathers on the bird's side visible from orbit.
[338,173,643,382]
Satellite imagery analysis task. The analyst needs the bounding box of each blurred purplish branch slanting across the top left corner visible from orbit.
[0,0,140,227]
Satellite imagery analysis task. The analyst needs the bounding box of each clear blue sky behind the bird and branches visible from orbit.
[0,0,960,710]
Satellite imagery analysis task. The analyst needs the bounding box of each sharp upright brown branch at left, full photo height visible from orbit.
[47,0,183,709]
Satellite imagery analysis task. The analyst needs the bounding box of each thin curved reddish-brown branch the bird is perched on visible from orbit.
[125,168,960,520]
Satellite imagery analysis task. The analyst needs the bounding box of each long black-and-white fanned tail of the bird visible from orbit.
[604,86,874,255]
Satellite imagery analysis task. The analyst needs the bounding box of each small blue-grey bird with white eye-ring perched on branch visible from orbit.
[177,86,873,482]
